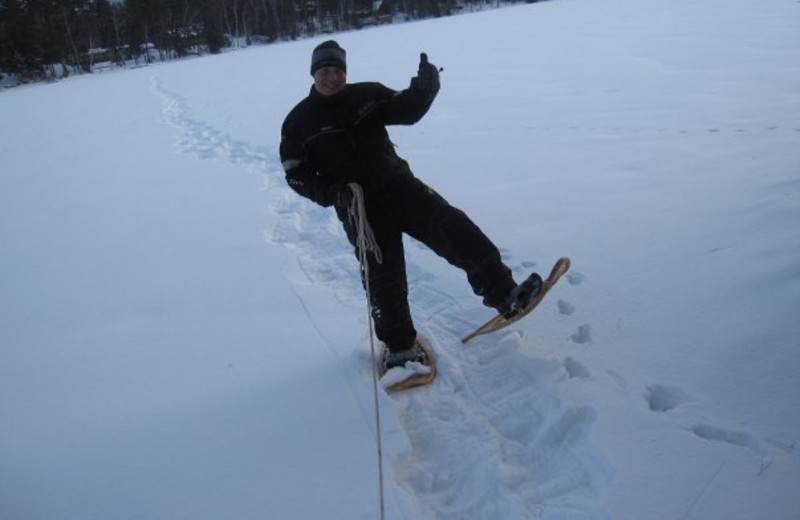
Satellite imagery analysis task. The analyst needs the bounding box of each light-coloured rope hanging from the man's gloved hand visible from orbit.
[347,182,386,520]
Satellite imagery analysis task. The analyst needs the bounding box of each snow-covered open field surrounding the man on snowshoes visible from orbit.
[0,0,800,520]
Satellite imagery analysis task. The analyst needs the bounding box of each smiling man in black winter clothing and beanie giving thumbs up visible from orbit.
[280,40,541,372]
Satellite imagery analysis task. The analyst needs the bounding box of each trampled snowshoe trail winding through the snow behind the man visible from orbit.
[151,71,611,518]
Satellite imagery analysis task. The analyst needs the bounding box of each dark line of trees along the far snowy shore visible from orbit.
[0,0,536,81]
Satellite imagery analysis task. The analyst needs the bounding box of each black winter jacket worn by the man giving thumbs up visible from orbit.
[280,82,436,206]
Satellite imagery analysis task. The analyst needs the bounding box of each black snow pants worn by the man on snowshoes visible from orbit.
[337,176,516,351]
